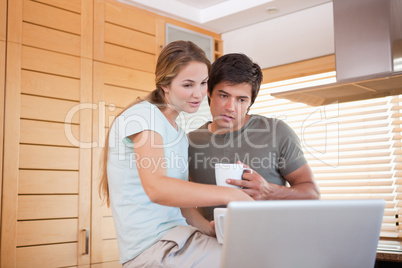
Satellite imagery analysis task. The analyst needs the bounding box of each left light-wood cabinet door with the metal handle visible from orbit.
[0,0,93,267]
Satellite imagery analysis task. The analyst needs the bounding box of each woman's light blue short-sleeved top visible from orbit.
[107,101,188,263]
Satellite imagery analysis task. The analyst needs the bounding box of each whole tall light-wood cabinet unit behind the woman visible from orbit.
[0,0,221,268]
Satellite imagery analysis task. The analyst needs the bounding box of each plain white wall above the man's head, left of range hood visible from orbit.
[222,2,334,69]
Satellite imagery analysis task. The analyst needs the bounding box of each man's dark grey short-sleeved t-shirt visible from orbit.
[188,115,307,220]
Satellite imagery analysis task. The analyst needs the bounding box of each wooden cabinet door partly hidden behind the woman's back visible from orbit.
[91,0,159,267]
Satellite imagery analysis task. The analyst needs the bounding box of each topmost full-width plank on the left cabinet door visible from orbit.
[23,0,81,35]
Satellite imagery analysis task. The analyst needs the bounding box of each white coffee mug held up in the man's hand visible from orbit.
[215,163,253,188]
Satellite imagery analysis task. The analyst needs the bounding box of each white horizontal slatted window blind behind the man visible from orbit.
[251,74,402,250]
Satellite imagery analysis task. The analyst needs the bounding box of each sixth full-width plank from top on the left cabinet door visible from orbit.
[20,119,79,146]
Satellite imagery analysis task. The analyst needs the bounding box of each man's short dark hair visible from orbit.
[208,53,262,107]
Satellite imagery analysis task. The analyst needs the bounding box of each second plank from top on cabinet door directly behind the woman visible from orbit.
[105,23,156,54]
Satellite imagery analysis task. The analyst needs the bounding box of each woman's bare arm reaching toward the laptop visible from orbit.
[130,130,253,208]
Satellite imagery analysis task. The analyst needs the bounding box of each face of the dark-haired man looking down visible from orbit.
[208,82,251,134]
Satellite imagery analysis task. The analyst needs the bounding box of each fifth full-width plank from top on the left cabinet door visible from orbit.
[21,95,79,124]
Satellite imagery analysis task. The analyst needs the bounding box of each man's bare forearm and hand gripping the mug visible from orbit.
[228,163,320,200]
